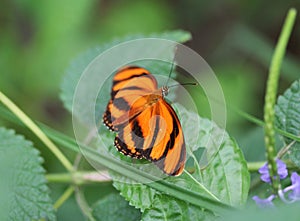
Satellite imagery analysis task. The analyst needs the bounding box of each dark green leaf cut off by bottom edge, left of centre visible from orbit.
[92,193,141,221]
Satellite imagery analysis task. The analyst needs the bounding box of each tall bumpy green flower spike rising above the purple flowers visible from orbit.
[264,9,297,192]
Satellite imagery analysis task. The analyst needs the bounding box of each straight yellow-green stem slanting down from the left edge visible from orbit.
[0,91,73,172]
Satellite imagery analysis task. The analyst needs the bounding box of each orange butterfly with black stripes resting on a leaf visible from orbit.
[103,66,186,176]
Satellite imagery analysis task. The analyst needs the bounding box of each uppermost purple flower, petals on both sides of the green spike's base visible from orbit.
[258,159,288,183]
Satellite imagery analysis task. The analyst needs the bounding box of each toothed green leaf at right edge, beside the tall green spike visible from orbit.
[275,80,300,166]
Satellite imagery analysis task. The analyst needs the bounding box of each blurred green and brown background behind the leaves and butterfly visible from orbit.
[0,0,300,220]
